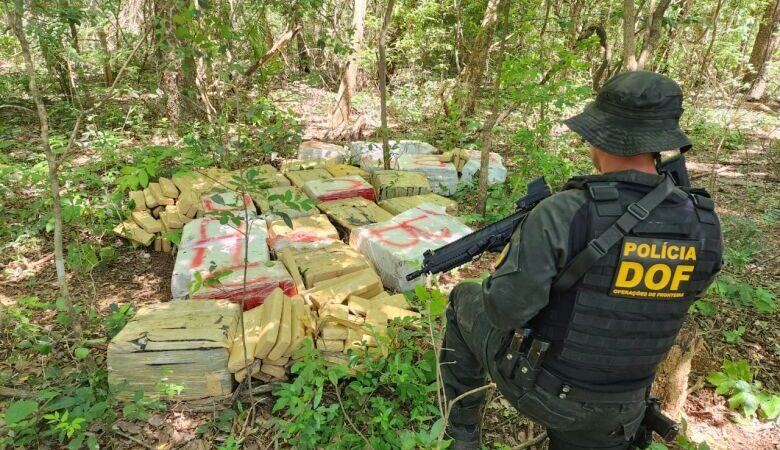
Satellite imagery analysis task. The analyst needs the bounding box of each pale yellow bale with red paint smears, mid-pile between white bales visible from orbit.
[268,214,339,254]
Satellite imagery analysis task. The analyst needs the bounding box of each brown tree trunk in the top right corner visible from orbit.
[742,0,780,100]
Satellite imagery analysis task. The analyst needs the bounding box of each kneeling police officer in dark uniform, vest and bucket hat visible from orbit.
[441,72,722,450]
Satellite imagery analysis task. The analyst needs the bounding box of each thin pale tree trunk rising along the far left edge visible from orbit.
[7,2,81,337]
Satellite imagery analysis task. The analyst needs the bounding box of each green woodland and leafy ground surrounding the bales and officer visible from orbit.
[0,0,780,449]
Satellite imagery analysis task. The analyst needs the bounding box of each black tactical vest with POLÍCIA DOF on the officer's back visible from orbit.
[532,177,722,392]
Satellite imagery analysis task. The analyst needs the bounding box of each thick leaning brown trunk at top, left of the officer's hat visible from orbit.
[458,0,506,116]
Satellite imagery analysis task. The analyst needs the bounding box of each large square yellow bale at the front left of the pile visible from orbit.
[107,300,240,400]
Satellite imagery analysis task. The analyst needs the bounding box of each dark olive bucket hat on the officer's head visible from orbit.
[564,71,692,156]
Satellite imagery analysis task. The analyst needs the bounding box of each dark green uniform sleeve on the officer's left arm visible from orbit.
[482,190,586,330]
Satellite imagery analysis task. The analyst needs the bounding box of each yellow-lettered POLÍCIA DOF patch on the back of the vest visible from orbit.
[610,237,701,299]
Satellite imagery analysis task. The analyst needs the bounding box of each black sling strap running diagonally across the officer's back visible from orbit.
[552,175,674,292]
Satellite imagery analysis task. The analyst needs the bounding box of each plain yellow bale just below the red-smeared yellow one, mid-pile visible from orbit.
[277,241,372,291]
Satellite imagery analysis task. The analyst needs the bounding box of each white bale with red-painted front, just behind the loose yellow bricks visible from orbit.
[192,261,298,310]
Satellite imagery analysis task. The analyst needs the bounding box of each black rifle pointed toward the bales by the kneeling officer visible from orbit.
[406,177,552,281]
